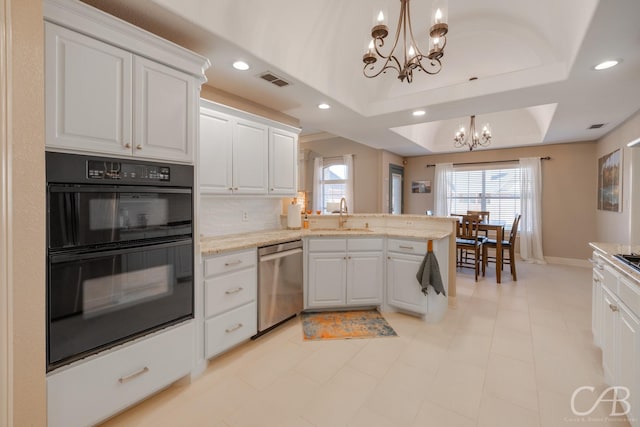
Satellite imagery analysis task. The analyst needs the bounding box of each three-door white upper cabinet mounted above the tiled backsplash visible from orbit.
[198,100,298,197]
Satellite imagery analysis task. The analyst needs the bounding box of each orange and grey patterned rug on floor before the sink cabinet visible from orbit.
[301,310,398,340]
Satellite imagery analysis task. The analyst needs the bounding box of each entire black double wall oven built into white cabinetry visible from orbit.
[46,152,194,371]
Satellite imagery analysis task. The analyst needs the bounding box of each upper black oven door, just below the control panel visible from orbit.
[47,184,193,250]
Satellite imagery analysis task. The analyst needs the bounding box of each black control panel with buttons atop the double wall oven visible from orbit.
[87,160,171,182]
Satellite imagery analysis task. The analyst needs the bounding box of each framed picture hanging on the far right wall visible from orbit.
[598,149,622,212]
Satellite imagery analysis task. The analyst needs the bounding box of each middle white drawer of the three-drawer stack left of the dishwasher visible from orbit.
[204,267,258,317]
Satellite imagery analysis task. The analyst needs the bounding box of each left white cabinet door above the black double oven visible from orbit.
[45,23,133,154]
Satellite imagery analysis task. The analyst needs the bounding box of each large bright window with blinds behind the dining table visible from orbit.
[447,167,521,224]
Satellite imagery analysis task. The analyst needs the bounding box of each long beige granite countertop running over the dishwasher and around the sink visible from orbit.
[200,227,451,255]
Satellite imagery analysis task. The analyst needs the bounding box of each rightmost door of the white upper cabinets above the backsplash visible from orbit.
[269,128,298,195]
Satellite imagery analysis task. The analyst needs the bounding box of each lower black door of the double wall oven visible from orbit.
[47,239,193,371]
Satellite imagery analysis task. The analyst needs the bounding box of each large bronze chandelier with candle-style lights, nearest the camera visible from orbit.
[362,0,449,83]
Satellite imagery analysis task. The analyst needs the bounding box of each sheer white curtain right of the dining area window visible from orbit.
[519,157,546,264]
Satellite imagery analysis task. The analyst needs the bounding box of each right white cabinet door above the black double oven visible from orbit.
[133,57,198,162]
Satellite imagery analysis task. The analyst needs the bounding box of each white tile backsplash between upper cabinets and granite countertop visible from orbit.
[199,196,282,236]
